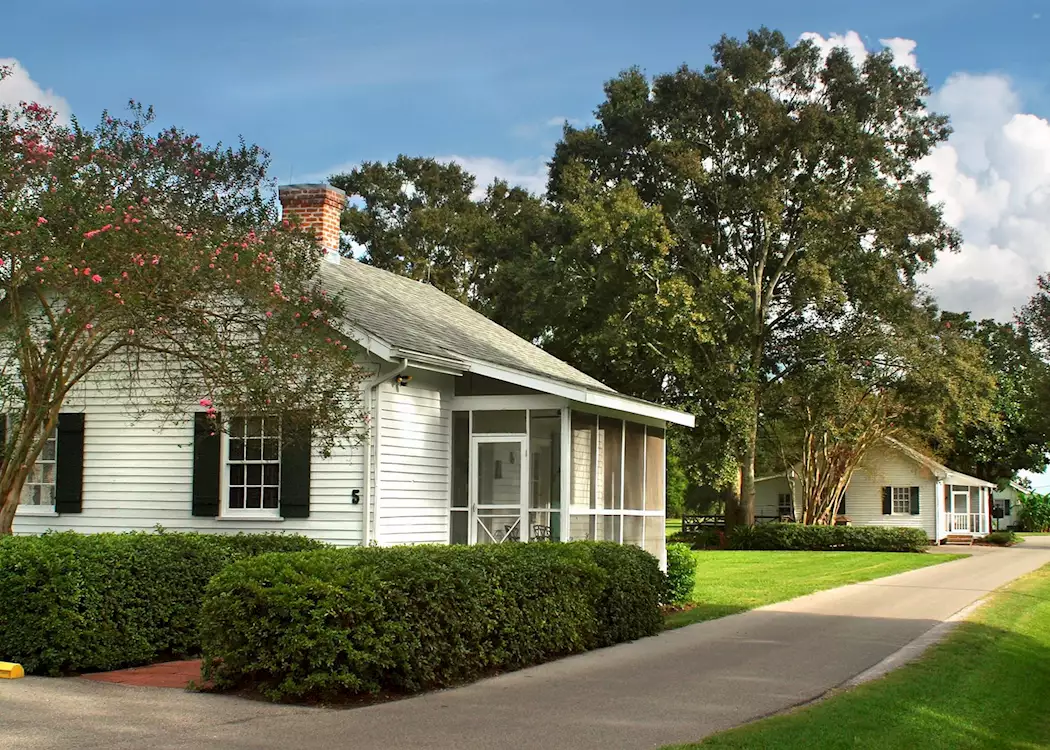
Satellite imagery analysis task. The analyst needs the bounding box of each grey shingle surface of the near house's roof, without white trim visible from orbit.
[320,258,615,393]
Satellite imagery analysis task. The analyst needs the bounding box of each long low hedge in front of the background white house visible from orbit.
[729,523,929,553]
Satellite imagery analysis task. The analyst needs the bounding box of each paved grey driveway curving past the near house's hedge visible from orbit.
[8,539,1050,750]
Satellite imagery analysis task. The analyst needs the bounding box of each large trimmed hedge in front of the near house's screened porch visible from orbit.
[201,542,665,701]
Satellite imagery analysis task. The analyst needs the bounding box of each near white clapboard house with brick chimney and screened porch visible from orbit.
[15,185,693,560]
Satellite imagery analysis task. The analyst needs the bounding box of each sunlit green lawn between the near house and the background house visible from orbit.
[666,549,965,627]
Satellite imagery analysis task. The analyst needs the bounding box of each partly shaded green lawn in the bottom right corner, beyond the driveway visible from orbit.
[667,566,1050,750]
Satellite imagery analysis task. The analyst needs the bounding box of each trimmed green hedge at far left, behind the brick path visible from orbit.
[0,532,323,674]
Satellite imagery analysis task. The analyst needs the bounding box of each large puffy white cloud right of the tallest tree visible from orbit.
[921,74,1050,320]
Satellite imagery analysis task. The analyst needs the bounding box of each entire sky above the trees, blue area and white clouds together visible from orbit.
[0,0,1050,486]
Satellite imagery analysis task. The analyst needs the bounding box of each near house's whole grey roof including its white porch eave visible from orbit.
[319,258,694,426]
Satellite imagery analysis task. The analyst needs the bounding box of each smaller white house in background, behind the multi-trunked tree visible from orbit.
[755,439,995,542]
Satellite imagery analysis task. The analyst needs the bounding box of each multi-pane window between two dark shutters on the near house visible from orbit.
[226,416,281,516]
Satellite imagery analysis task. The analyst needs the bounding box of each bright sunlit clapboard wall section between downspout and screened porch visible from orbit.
[376,370,454,545]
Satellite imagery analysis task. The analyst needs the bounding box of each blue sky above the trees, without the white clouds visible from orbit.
[0,0,1050,182]
